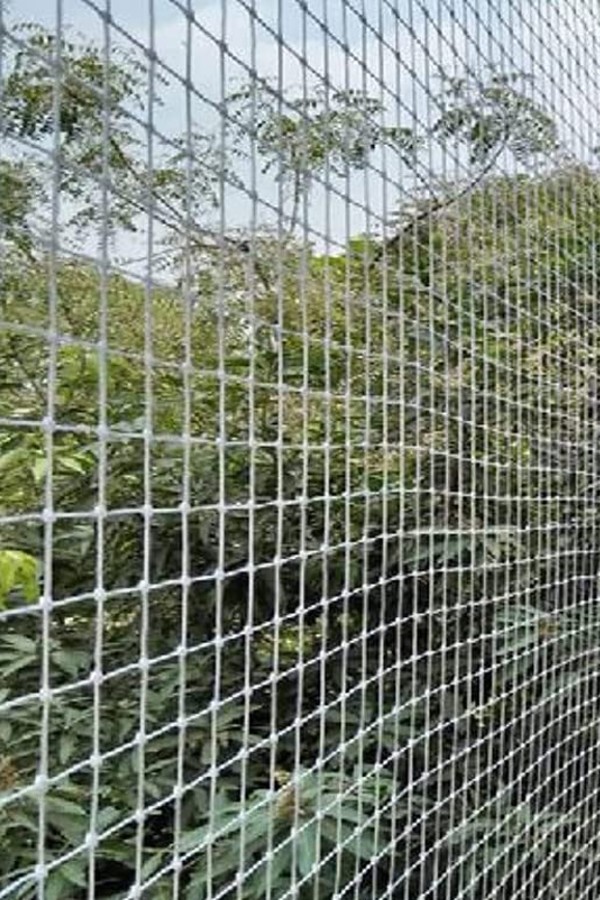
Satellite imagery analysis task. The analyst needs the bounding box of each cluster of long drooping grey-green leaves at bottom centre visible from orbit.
[175,770,393,900]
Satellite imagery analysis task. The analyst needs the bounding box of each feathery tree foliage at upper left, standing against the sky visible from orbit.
[0,23,224,242]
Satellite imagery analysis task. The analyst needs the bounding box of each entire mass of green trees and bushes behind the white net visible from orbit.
[0,14,600,900]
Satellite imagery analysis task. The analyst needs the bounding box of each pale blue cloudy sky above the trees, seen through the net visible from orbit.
[0,0,600,272]
